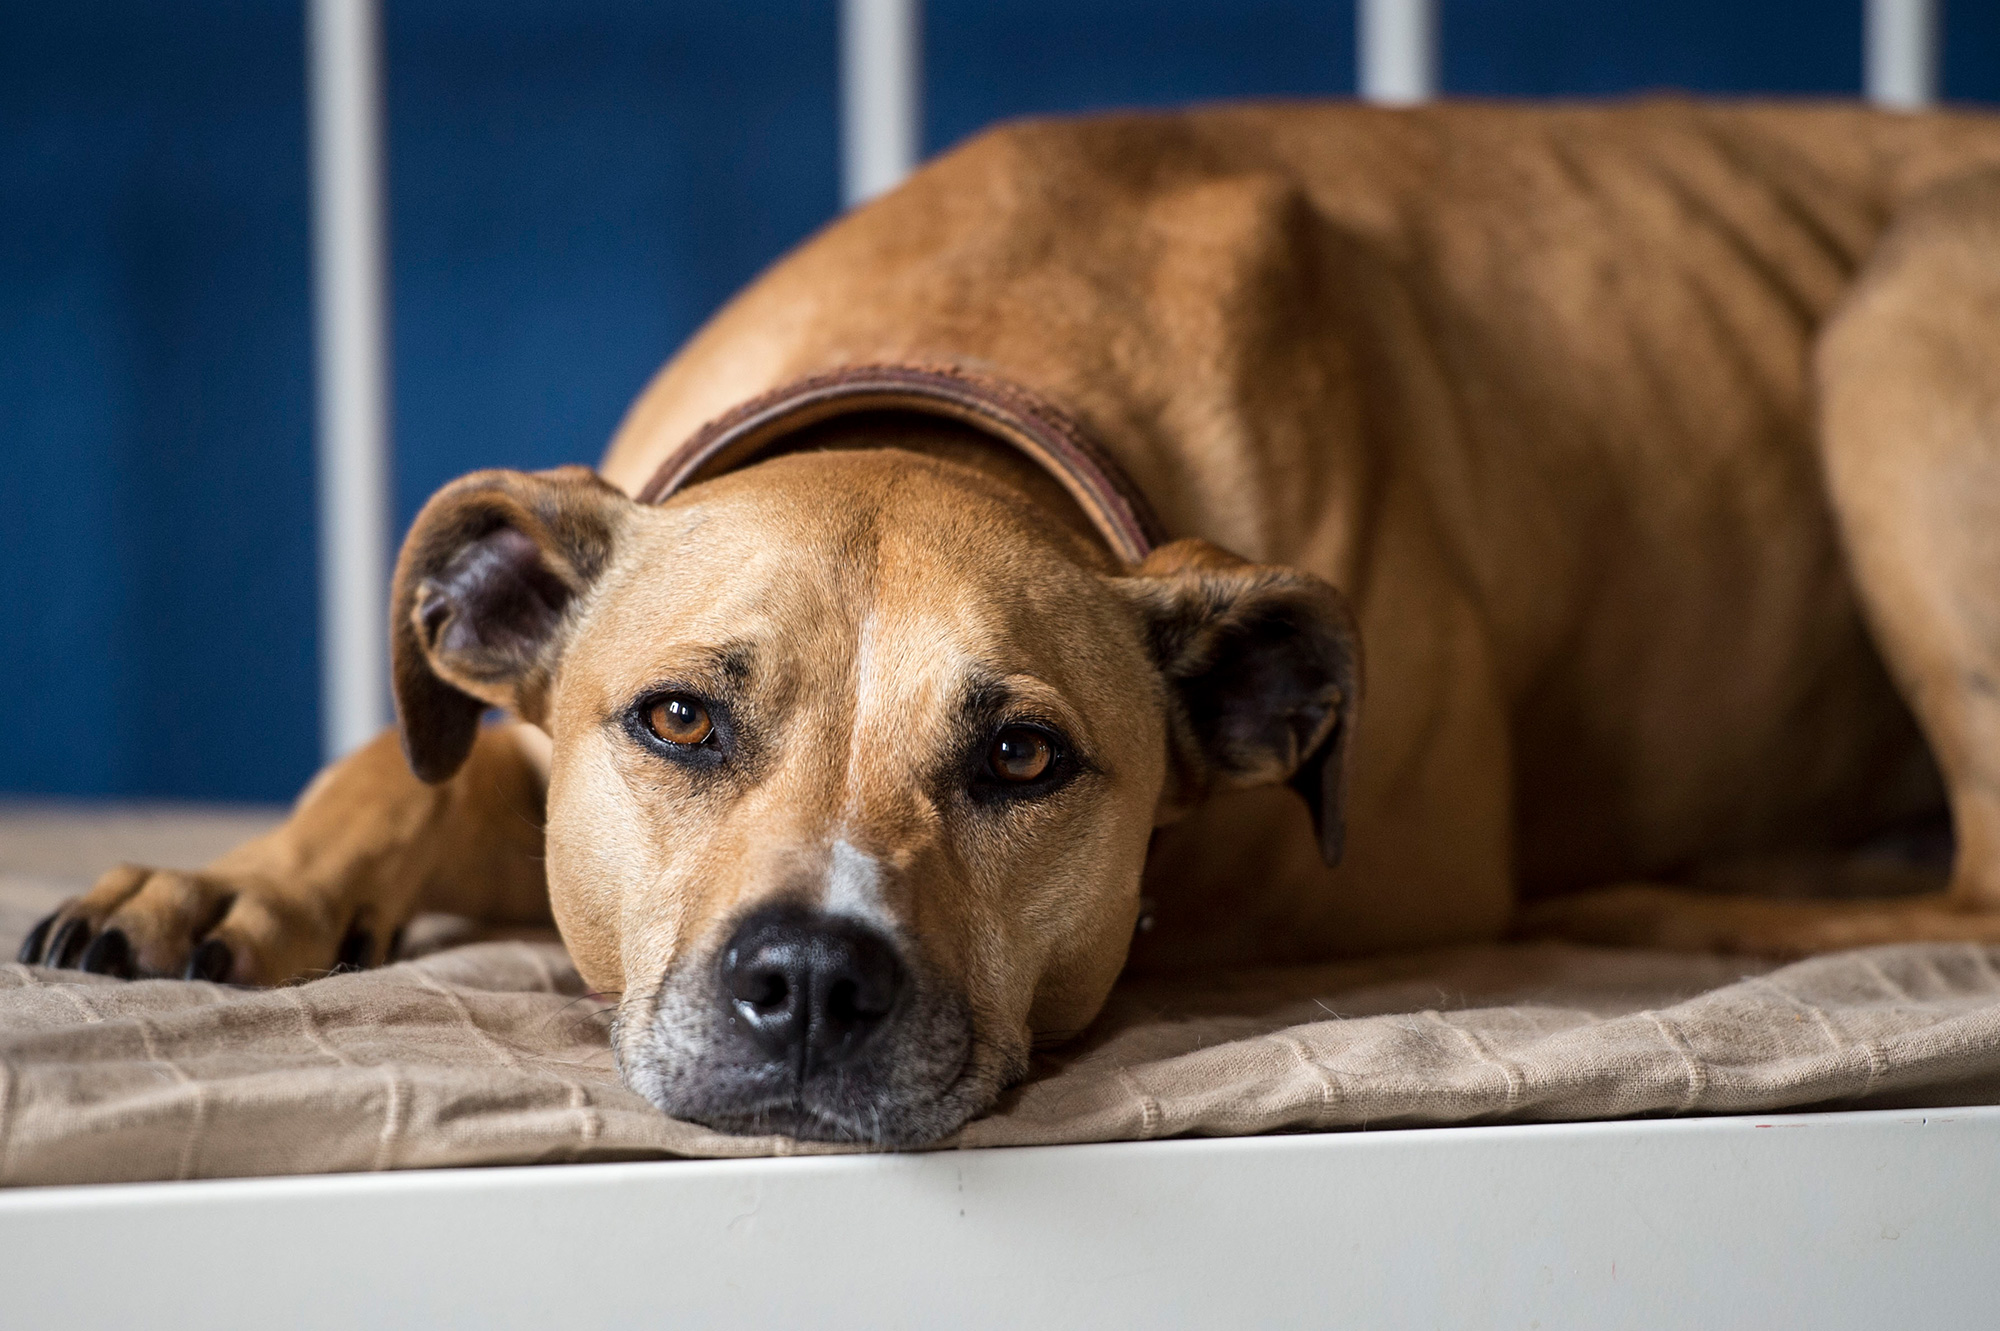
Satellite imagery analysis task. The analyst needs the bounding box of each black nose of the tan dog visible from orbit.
[722,907,904,1077]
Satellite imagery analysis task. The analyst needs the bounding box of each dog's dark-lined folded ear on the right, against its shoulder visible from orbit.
[1116,540,1362,865]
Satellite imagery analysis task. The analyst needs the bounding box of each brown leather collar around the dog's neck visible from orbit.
[638,366,1164,564]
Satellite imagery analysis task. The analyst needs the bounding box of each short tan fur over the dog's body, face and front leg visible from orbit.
[35,102,2000,1127]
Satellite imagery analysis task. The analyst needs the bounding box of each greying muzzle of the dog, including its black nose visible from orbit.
[616,905,980,1145]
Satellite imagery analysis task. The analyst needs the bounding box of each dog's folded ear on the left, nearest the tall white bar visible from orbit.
[390,468,634,781]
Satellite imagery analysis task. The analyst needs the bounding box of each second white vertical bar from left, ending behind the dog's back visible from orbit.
[840,0,924,208]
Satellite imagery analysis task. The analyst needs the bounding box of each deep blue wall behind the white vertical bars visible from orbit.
[11,0,2000,799]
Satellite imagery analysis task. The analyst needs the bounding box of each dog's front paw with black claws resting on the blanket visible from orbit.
[18,863,388,985]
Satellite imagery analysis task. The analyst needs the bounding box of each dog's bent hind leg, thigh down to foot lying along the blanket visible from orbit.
[1516,172,2000,955]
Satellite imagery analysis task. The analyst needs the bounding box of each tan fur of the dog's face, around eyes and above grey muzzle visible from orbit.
[550,456,1164,1087]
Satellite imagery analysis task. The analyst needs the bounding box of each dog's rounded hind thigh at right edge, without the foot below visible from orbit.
[1816,172,2000,911]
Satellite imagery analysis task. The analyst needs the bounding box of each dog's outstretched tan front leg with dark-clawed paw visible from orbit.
[20,725,548,985]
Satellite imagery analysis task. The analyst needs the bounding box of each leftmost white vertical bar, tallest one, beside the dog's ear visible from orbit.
[306,0,388,759]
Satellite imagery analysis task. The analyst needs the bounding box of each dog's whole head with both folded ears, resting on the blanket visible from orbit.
[394,450,1358,1145]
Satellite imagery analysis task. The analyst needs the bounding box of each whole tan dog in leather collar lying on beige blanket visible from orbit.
[24,102,2000,1143]
